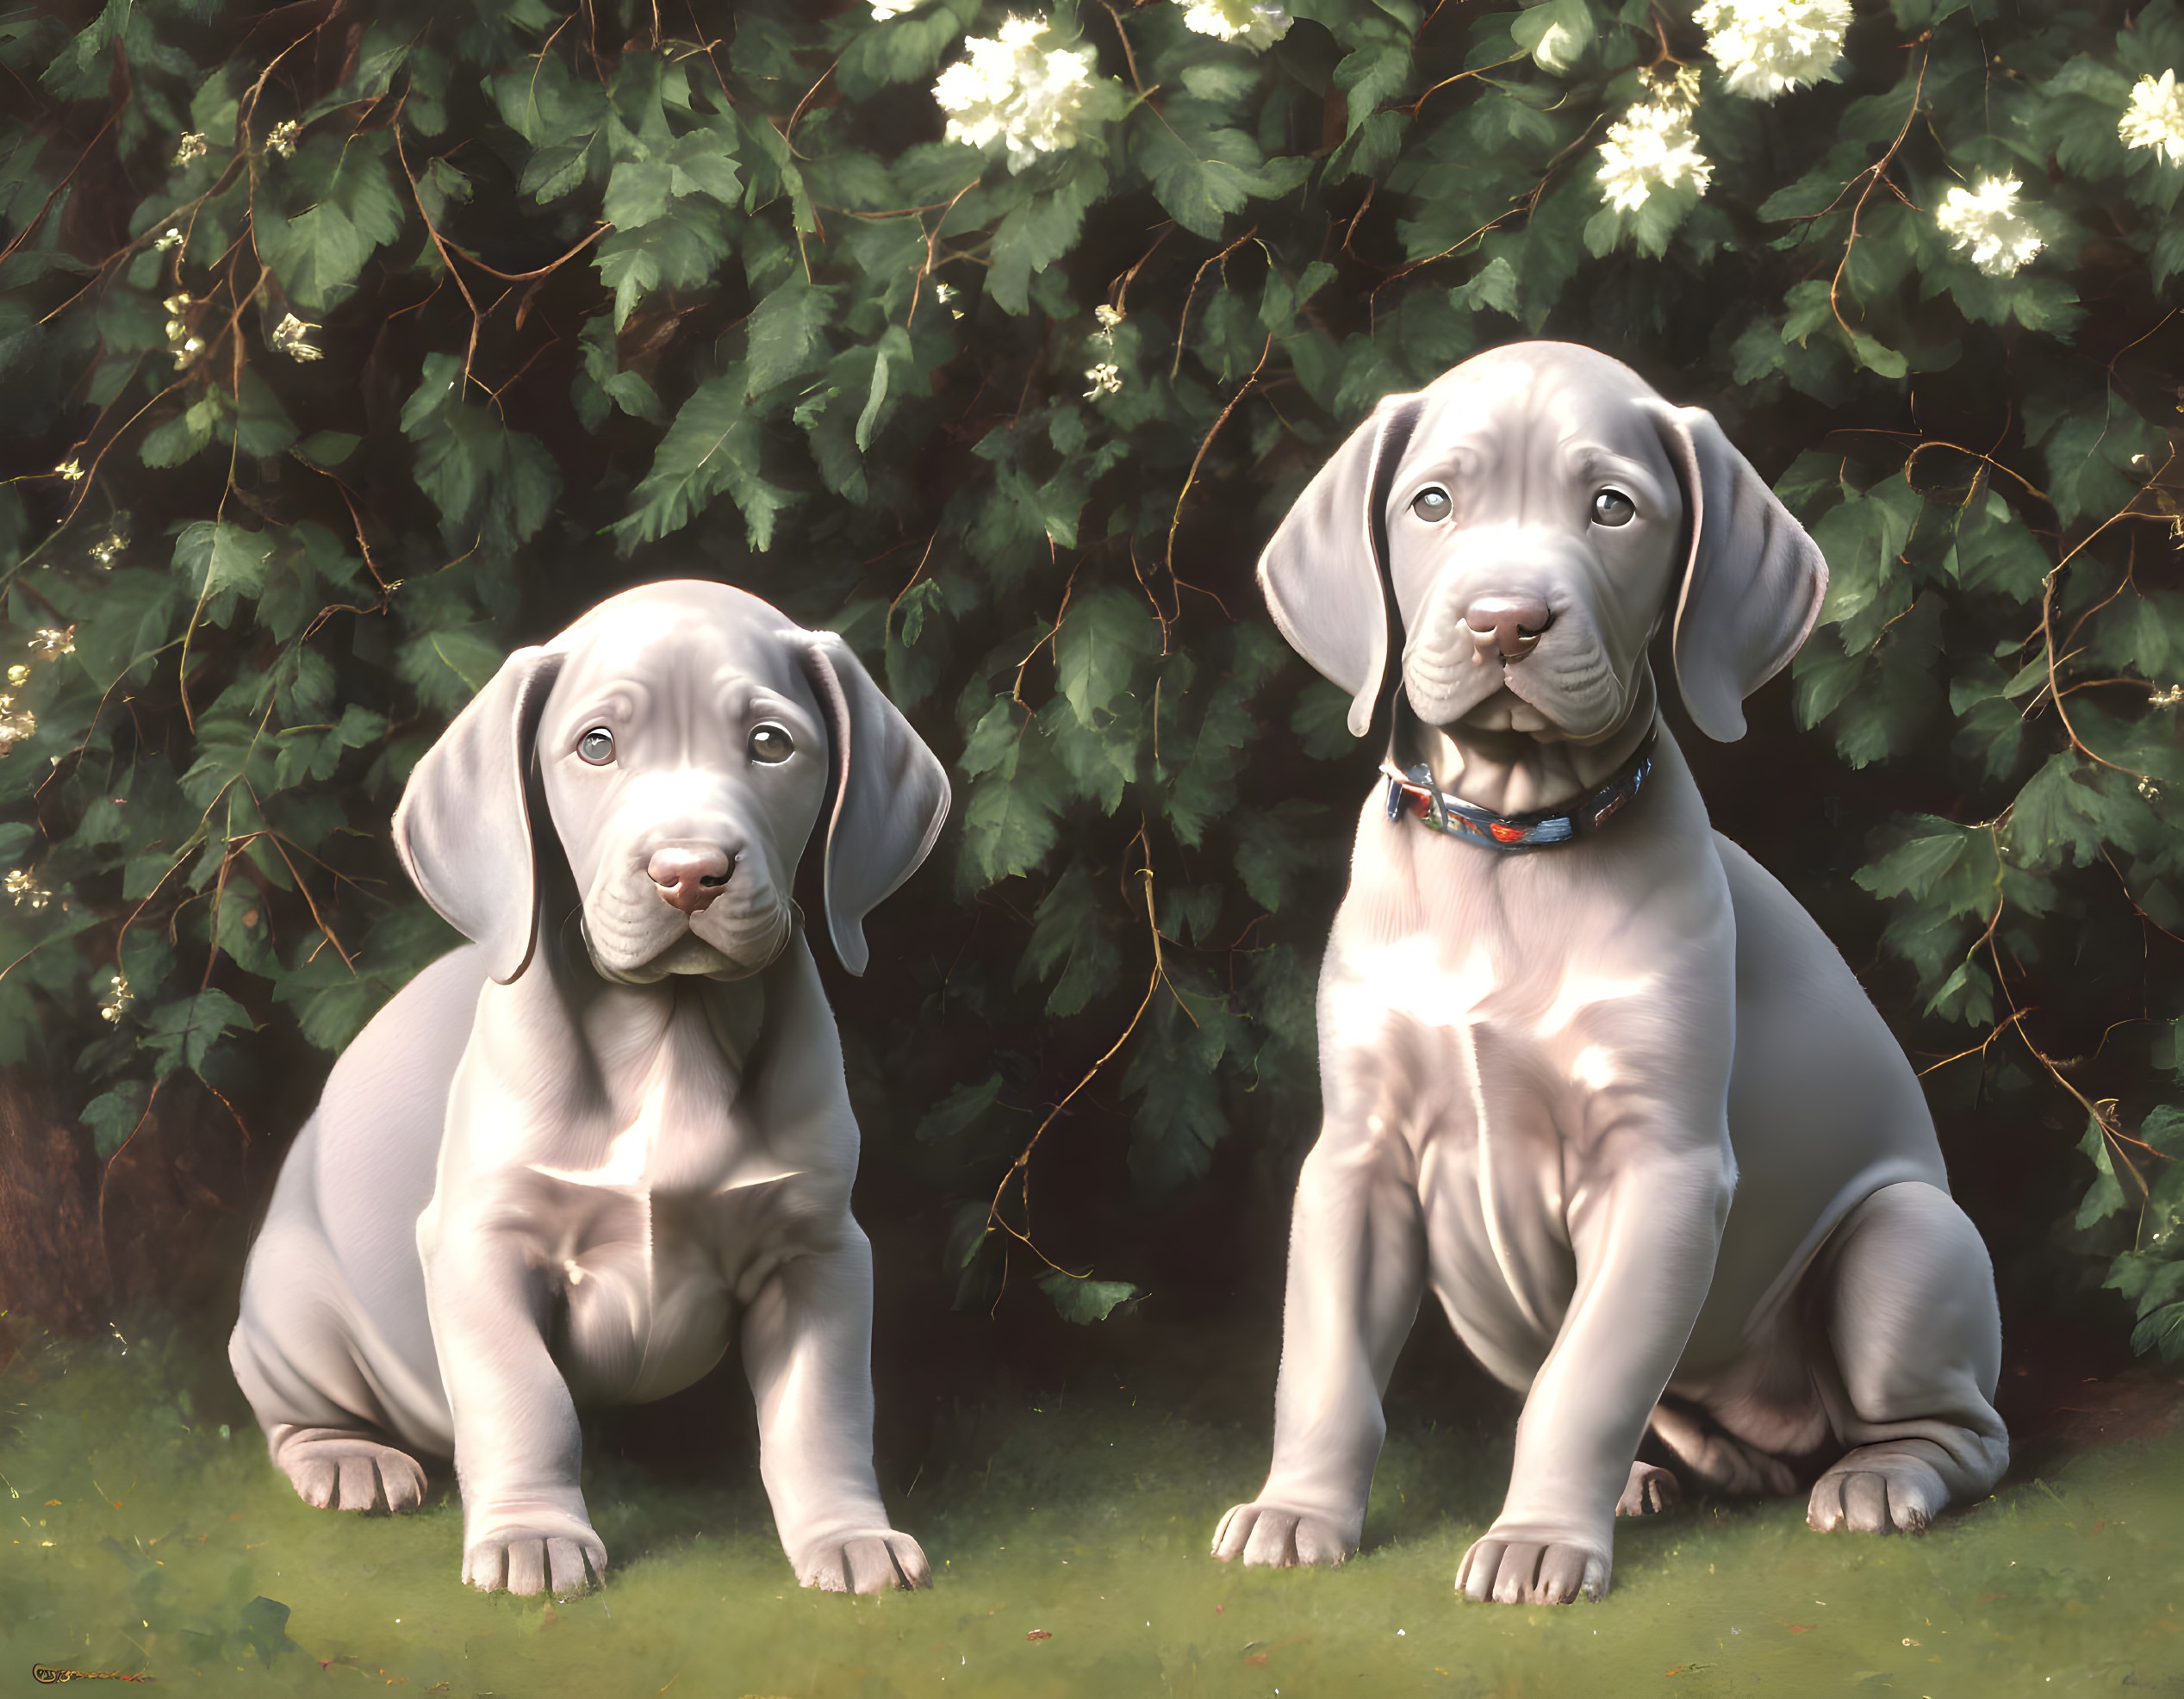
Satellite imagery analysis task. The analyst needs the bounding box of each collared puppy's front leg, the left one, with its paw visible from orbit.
[1214,1127,1426,1565]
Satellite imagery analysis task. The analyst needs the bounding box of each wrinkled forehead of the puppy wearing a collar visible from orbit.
[1400,345,1675,485]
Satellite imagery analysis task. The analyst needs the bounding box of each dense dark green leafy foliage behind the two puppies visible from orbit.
[0,0,2184,1354]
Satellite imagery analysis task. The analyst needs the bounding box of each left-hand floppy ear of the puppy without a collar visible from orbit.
[395,649,563,985]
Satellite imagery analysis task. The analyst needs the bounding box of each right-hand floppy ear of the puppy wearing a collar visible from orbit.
[1638,395,1828,743]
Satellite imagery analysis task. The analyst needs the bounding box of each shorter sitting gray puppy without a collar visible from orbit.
[229,581,948,1594]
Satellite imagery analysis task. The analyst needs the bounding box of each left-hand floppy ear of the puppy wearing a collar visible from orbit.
[1258,393,1420,738]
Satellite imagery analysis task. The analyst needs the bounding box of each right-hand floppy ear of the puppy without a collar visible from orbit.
[782,632,948,974]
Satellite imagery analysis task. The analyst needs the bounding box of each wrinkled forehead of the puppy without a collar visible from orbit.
[548,596,817,714]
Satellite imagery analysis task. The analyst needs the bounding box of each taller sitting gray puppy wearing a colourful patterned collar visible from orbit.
[1214,343,2009,1603]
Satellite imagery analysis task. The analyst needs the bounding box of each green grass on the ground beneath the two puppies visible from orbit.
[0,1339,2184,1699]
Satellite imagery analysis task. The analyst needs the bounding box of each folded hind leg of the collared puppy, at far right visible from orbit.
[1806,1179,2009,1533]
